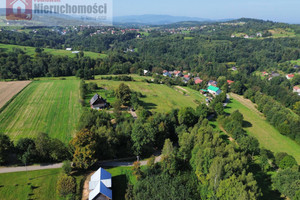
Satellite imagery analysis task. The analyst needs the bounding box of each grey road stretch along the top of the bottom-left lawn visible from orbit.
[0,163,62,174]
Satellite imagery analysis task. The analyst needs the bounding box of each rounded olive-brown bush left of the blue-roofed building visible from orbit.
[56,174,76,197]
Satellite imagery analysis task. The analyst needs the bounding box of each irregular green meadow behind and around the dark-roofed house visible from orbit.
[89,77,205,112]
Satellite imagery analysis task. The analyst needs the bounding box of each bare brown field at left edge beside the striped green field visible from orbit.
[0,81,31,108]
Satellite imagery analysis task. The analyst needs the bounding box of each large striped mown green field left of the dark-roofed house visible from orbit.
[0,80,82,143]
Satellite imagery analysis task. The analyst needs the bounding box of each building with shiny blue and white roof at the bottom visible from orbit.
[89,167,112,200]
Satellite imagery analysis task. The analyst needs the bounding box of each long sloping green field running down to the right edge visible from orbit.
[225,94,300,163]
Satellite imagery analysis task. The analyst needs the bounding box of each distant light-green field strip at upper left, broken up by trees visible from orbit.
[0,44,107,59]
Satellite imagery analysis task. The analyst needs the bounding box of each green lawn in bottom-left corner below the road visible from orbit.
[0,169,61,200]
